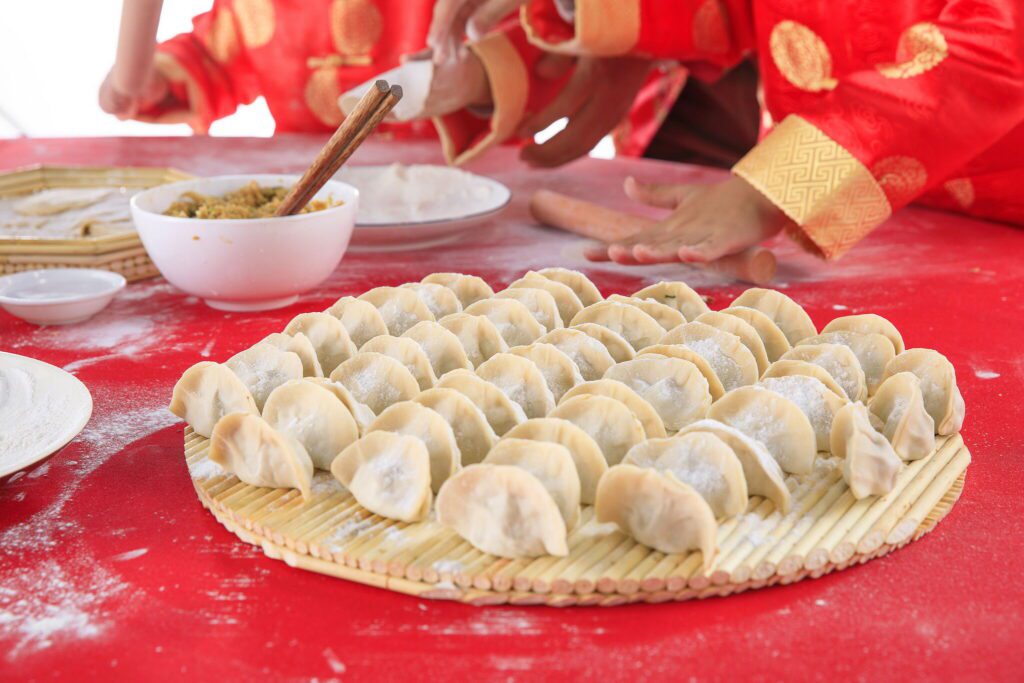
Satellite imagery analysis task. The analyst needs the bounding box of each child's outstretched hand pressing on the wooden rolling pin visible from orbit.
[586,176,788,264]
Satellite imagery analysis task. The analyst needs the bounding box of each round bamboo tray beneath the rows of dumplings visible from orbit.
[184,427,971,606]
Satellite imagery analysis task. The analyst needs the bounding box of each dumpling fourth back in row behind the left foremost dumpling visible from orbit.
[548,394,647,465]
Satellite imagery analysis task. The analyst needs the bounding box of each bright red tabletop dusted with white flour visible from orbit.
[0,136,1024,680]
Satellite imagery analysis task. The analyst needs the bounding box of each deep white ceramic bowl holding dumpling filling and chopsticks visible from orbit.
[131,174,359,310]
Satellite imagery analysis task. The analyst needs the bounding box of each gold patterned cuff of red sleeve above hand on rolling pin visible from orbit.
[732,115,892,259]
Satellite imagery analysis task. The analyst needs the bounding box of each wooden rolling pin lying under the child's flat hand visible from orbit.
[529,189,776,286]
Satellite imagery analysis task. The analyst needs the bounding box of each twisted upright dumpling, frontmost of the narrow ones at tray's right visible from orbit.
[831,403,903,500]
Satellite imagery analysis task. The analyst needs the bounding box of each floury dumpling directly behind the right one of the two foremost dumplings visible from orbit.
[623,432,746,518]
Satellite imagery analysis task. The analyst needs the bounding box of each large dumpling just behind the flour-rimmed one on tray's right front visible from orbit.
[708,386,818,474]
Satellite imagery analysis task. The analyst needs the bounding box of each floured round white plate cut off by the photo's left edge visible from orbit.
[0,351,92,477]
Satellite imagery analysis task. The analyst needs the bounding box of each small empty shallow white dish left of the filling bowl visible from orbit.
[0,268,125,325]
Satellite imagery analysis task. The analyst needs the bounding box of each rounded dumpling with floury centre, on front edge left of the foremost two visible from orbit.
[331,432,432,522]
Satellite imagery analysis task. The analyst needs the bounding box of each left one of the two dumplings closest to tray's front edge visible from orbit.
[436,464,569,559]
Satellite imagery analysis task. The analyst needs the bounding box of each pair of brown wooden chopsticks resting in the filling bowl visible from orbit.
[273,81,401,216]
